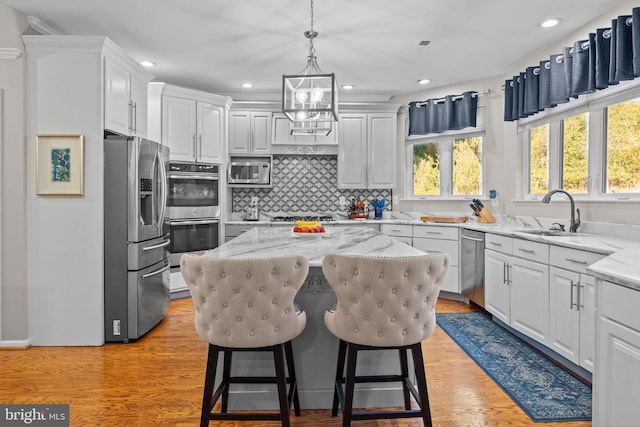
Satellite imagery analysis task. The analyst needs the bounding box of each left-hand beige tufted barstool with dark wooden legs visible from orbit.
[180,254,309,427]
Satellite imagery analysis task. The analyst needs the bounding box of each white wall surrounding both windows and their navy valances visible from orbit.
[391,1,640,224]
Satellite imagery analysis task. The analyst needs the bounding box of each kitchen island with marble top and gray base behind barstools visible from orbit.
[204,227,424,409]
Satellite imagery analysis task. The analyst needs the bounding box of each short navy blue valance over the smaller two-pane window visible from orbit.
[409,91,478,135]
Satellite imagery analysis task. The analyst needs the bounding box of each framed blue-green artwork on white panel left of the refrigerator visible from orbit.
[36,135,84,196]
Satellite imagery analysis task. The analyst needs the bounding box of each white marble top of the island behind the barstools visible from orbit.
[205,227,424,267]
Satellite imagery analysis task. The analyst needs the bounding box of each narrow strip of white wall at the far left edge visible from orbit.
[0,2,29,346]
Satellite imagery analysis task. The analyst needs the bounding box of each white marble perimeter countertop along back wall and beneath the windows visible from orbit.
[225,211,640,290]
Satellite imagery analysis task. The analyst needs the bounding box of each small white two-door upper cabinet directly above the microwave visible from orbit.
[229,111,272,154]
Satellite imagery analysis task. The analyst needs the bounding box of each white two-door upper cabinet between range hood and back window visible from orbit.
[338,110,397,188]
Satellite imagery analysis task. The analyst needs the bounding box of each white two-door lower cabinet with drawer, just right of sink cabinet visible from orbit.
[549,246,604,372]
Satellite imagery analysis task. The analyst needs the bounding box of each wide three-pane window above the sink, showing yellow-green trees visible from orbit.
[519,87,640,200]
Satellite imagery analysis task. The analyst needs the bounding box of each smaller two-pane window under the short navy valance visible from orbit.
[407,133,483,197]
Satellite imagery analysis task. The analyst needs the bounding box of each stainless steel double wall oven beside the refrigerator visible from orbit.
[166,162,220,269]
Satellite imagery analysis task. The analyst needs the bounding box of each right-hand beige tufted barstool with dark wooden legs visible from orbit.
[322,253,449,427]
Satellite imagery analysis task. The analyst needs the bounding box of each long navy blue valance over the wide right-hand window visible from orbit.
[504,7,640,121]
